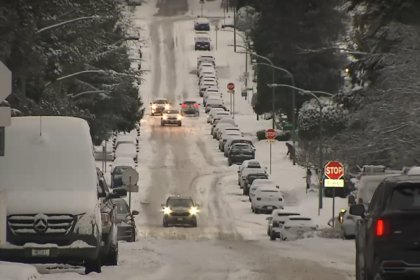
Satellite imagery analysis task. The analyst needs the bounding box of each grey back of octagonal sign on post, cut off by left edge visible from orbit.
[0,61,12,246]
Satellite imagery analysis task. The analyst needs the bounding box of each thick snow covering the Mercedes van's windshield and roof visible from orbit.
[0,116,97,192]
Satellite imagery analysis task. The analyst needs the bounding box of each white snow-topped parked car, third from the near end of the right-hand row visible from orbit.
[251,186,284,214]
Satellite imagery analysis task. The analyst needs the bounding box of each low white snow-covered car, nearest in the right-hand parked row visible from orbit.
[280,216,317,241]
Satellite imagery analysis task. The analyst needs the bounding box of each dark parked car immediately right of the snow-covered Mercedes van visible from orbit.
[113,199,139,242]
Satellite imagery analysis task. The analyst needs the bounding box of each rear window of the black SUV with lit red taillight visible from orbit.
[389,184,420,211]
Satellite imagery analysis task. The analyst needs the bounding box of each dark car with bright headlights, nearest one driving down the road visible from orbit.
[162,195,199,227]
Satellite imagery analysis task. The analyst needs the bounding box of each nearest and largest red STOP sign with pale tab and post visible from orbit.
[324,161,344,228]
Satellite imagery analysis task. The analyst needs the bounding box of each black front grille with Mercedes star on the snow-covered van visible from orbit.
[7,214,75,235]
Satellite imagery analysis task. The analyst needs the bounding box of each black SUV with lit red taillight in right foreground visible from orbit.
[350,175,420,280]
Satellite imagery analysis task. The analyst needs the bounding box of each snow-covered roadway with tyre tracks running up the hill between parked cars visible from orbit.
[0,0,351,280]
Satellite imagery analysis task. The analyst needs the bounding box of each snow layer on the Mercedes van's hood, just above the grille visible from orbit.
[6,189,98,215]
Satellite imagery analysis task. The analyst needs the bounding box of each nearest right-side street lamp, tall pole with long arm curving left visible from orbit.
[268,84,333,215]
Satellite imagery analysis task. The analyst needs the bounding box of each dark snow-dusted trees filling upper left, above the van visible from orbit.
[0,0,142,141]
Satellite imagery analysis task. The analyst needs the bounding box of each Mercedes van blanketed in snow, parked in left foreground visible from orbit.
[0,117,102,273]
